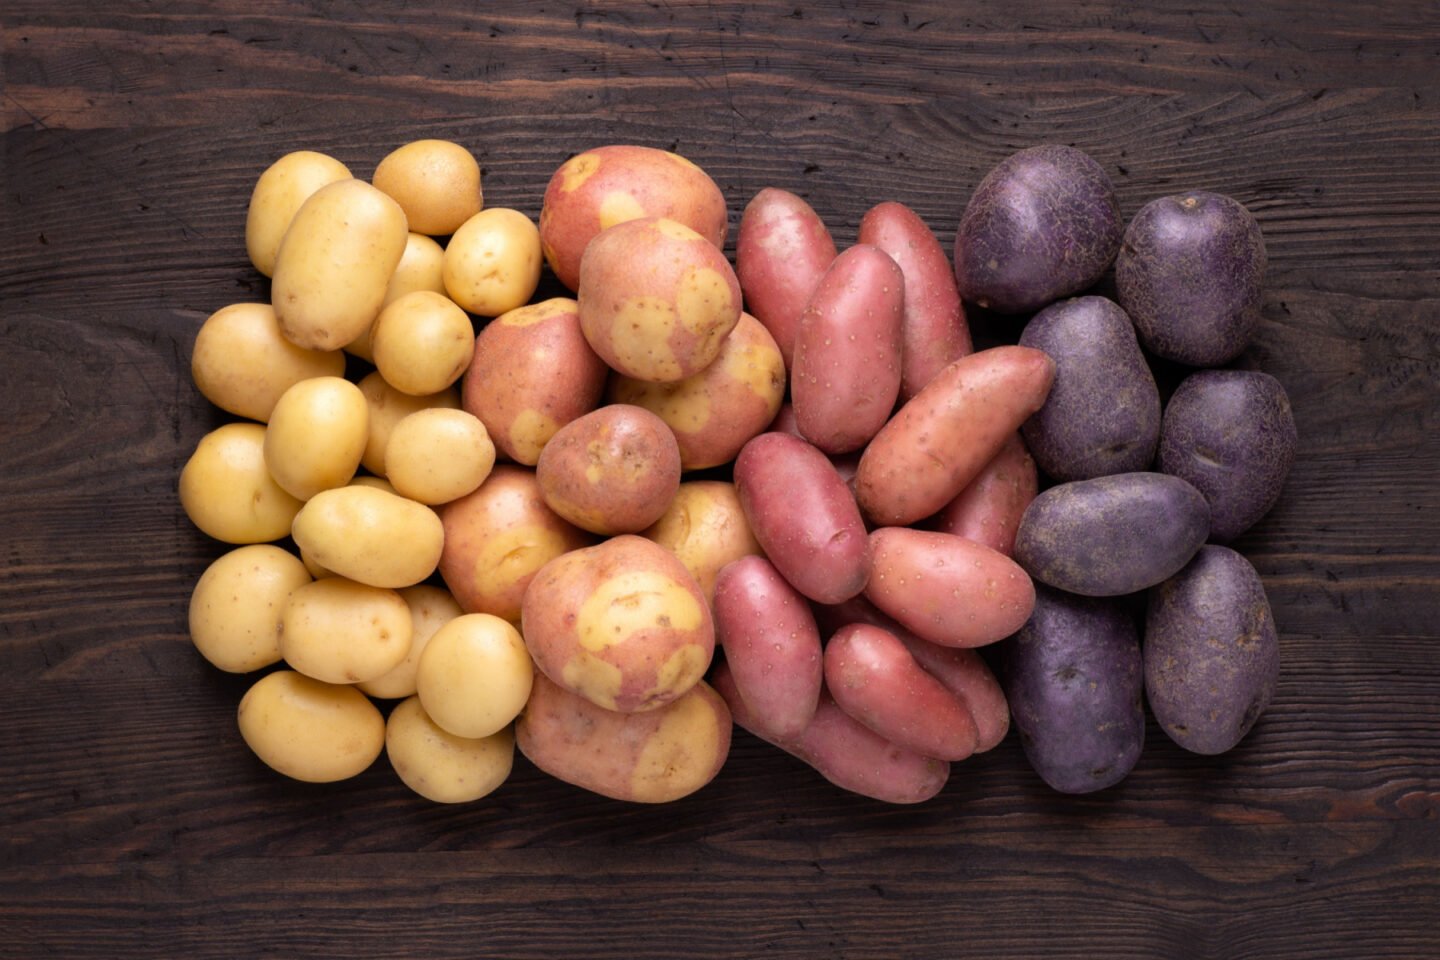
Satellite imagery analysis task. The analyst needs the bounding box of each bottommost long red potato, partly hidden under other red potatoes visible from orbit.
[710,664,950,803]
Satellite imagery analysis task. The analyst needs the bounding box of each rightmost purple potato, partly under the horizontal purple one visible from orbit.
[1152,370,1296,543]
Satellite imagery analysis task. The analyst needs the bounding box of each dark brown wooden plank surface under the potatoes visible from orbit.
[0,0,1440,960]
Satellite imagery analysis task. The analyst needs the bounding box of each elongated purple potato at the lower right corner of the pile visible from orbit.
[1145,545,1280,754]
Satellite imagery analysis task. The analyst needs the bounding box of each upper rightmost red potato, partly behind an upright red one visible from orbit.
[860,200,973,400]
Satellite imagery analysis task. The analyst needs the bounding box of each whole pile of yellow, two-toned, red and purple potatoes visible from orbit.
[180,140,1295,803]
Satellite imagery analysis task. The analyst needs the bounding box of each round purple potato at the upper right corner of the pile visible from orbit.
[1115,190,1266,367]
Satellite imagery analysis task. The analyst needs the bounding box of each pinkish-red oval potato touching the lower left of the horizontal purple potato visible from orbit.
[865,527,1035,646]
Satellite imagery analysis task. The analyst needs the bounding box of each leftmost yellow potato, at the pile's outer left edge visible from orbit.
[180,423,302,544]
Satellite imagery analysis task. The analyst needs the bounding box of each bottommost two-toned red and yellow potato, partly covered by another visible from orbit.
[516,674,730,803]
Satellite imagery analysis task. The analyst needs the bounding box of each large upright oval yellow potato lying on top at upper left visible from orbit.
[271,180,409,350]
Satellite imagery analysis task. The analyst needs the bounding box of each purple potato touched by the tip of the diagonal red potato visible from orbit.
[1020,296,1161,481]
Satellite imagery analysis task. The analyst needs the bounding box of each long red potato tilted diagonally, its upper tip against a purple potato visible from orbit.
[855,347,1056,527]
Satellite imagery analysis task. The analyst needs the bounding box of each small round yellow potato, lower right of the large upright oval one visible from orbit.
[370,291,475,397]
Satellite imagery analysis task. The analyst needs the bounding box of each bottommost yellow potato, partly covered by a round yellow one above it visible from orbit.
[384,697,516,803]
